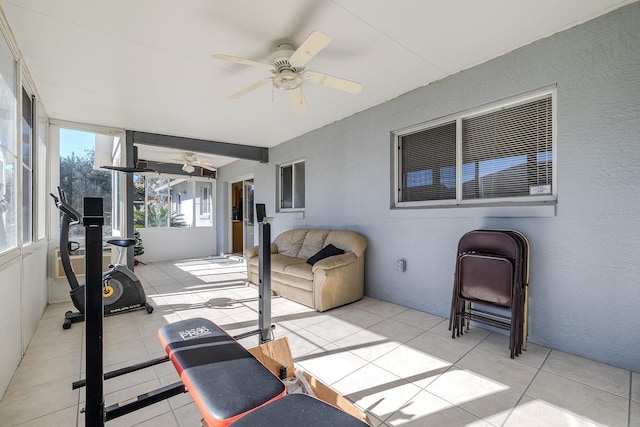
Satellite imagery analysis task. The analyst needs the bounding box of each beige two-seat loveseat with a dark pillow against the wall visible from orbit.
[244,229,367,311]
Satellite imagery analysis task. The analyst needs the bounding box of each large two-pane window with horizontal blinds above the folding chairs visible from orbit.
[394,91,555,207]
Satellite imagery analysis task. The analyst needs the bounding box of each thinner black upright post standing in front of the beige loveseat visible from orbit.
[258,222,271,344]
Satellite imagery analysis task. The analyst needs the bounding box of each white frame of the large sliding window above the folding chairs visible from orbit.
[391,86,558,209]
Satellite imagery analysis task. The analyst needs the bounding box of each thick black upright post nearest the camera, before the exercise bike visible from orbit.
[82,197,105,426]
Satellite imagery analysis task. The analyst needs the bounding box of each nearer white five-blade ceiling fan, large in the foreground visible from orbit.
[211,31,362,114]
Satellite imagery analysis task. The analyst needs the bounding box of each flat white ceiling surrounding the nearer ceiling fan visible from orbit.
[0,0,634,166]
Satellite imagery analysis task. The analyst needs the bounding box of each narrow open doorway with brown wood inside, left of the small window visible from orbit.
[231,179,255,255]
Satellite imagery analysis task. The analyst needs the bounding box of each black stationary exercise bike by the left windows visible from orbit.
[50,187,153,329]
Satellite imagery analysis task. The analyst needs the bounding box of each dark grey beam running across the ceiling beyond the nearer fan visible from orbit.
[127,130,269,163]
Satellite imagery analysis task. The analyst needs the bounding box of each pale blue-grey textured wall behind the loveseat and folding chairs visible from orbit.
[216,3,640,371]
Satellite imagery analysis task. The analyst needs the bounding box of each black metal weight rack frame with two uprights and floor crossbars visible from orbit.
[77,197,275,426]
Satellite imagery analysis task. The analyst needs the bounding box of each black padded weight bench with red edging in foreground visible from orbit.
[158,318,367,427]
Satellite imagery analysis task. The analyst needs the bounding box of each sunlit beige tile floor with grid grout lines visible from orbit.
[0,257,640,427]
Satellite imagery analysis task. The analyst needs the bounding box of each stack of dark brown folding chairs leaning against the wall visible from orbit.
[449,230,529,358]
